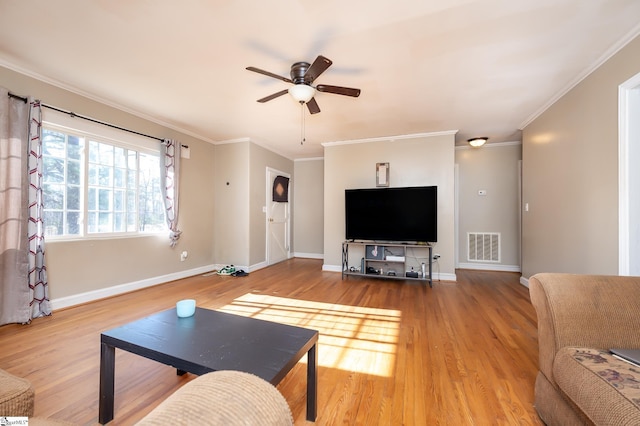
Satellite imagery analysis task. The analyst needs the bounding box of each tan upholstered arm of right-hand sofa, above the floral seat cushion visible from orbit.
[529,273,640,385]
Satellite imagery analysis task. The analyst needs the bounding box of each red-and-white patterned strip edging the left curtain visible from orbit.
[27,99,51,318]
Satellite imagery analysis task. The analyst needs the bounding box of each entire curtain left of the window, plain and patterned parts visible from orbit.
[0,88,51,325]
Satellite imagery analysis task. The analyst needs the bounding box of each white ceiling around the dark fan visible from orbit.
[0,0,640,159]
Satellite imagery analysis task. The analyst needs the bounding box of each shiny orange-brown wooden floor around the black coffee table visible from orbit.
[0,259,542,425]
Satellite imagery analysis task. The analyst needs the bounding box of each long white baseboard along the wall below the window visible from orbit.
[51,265,218,311]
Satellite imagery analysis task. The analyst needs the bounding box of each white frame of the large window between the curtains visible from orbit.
[42,108,169,241]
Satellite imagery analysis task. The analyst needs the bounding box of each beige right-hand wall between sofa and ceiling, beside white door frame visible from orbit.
[522,37,640,278]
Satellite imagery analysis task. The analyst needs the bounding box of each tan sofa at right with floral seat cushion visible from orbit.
[529,273,640,426]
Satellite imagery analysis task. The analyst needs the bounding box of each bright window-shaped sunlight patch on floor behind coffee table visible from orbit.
[218,293,401,377]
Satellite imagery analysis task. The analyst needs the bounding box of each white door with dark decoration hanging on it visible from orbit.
[266,167,291,265]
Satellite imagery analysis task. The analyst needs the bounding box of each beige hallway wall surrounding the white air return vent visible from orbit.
[456,142,522,272]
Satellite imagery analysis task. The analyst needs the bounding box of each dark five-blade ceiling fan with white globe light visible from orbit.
[247,55,360,114]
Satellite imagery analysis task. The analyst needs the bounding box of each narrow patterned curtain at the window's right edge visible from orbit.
[160,139,182,247]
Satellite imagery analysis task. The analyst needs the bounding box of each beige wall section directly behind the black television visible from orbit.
[324,132,455,280]
